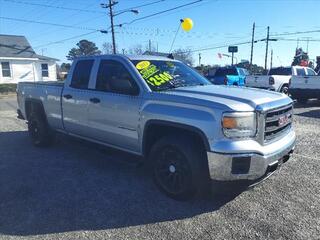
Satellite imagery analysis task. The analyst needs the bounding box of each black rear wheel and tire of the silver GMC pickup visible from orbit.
[28,112,54,147]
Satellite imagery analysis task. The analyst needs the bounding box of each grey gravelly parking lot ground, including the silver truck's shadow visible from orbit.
[0,94,320,239]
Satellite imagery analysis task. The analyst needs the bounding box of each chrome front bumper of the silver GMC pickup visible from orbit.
[207,131,296,181]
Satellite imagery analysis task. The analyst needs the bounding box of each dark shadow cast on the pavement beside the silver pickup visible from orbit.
[0,131,244,236]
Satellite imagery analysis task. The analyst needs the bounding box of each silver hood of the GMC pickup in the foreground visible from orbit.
[162,85,292,111]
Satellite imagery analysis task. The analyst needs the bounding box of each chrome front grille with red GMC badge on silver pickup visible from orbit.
[264,104,293,142]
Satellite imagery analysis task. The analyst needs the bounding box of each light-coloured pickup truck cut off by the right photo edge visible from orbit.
[289,69,320,103]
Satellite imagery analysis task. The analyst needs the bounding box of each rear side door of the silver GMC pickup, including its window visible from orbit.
[62,59,94,136]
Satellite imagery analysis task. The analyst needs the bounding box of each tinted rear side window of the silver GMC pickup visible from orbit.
[71,60,93,89]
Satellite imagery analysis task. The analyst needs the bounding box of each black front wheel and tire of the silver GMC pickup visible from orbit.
[149,135,209,200]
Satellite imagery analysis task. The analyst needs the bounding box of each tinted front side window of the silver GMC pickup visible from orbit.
[96,60,138,95]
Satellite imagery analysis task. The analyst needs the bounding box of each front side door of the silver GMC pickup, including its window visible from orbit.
[88,59,141,152]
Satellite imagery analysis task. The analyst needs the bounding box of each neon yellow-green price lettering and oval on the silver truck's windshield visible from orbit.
[136,61,173,86]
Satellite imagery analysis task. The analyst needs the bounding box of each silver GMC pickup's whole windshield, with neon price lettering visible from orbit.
[131,60,211,91]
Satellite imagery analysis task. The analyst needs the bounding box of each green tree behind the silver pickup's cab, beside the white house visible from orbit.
[67,40,101,61]
